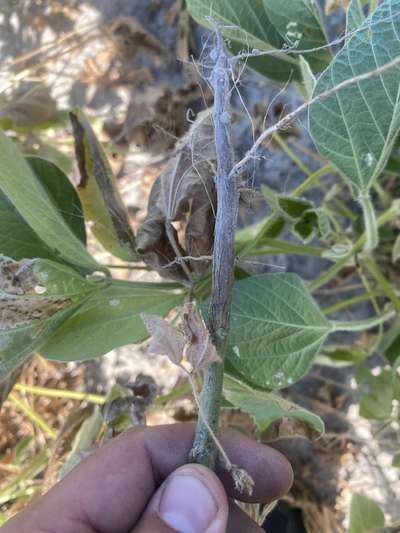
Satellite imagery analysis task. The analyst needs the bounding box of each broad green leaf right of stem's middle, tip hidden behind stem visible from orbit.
[227,273,332,389]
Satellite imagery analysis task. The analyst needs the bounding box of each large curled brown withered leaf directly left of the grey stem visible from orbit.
[137,111,216,281]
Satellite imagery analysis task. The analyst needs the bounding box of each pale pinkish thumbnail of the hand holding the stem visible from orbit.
[159,472,218,533]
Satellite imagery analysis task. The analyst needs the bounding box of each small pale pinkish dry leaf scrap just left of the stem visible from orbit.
[141,314,185,365]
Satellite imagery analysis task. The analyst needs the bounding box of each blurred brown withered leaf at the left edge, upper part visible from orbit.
[0,85,57,128]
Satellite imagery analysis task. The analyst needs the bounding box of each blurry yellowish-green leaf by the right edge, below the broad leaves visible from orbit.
[355,367,399,420]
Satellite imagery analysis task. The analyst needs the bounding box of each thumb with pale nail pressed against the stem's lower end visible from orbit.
[132,464,228,533]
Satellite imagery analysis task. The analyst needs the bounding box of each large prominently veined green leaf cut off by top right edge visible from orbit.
[309,0,400,196]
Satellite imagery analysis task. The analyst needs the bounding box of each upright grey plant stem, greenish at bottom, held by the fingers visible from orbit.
[190,21,239,469]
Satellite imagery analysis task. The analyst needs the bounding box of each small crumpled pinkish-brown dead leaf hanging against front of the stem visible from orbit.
[180,302,221,371]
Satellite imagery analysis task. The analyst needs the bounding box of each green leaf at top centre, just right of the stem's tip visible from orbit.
[186,0,301,82]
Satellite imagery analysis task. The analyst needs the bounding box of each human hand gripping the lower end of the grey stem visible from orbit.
[1,424,293,533]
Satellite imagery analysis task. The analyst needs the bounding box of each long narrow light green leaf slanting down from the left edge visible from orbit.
[0,132,99,270]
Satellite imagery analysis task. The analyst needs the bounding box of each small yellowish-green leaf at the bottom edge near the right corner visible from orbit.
[348,493,385,533]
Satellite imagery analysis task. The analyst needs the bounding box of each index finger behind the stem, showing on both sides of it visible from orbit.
[5,424,293,533]
